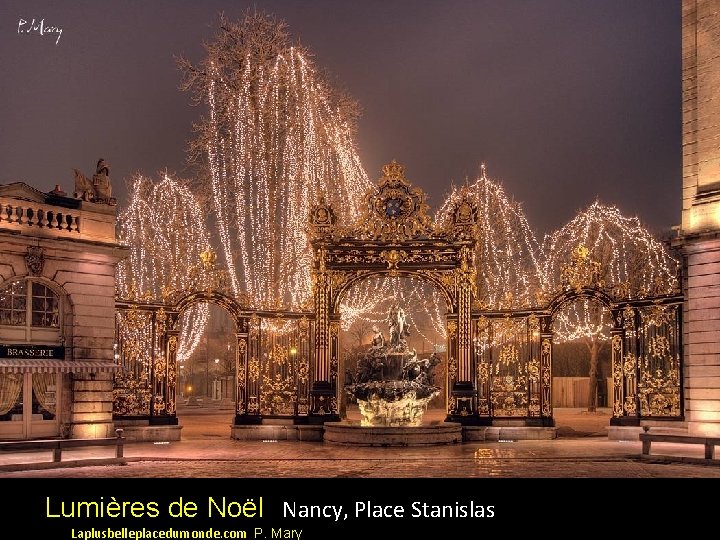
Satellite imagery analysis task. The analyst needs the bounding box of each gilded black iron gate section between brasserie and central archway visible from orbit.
[113,291,315,424]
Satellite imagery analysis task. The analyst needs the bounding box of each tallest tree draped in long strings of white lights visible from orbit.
[180,11,370,309]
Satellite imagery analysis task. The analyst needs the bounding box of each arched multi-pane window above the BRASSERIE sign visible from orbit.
[0,279,62,343]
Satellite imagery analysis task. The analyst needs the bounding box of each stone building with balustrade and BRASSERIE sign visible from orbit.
[0,182,125,439]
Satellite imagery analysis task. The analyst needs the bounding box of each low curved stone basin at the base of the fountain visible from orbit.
[323,420,463,446]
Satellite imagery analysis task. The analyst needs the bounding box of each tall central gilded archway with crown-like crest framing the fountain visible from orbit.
[310,161,477,420]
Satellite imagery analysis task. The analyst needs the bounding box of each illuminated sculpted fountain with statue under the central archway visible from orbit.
[345,305,440,427]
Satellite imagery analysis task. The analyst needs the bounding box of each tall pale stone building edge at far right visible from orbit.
[678,0,720,435]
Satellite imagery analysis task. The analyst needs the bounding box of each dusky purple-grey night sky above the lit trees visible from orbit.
[0,0,682,236]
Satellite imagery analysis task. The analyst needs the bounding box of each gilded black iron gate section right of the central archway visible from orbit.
[473,289,683,425]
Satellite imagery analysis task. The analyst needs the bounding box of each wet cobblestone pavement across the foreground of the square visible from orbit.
[0,411,720,478]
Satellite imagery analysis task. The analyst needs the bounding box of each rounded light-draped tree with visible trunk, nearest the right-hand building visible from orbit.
[543,202,678,412]
